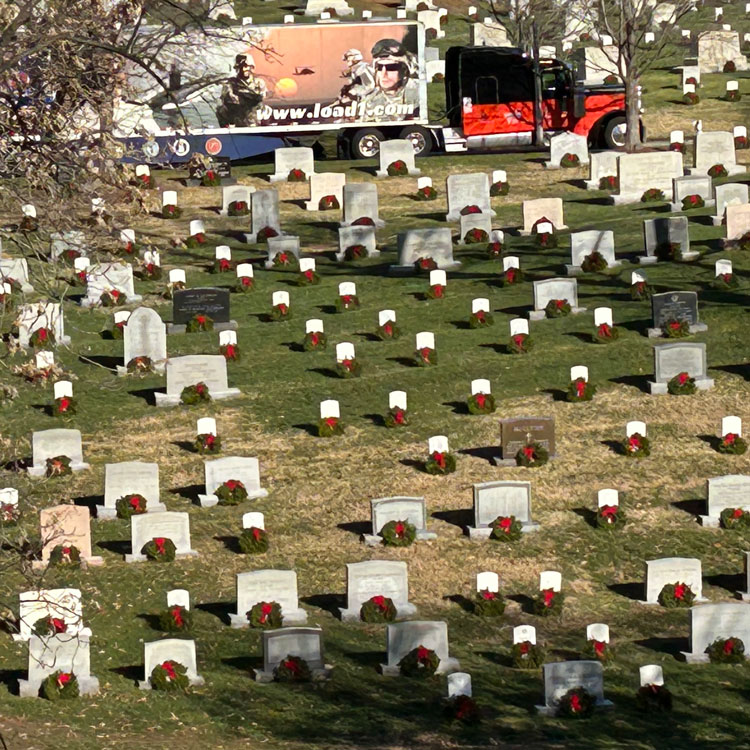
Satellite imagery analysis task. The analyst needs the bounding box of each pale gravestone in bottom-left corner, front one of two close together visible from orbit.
[18,633,99,698]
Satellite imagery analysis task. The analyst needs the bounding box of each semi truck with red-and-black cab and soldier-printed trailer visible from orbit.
[114,20,636,164]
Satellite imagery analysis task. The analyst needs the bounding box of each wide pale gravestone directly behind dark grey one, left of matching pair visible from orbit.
[229,570,307,628]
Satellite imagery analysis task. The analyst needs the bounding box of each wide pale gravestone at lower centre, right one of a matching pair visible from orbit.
[340,560,417,622]
